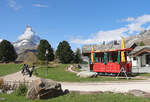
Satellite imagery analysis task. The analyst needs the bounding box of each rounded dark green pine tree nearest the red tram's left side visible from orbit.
[56,41,74,64]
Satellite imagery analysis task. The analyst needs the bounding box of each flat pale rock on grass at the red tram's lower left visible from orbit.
[77,71,97,78]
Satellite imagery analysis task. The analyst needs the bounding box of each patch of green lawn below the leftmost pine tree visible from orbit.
[0,64,22,76]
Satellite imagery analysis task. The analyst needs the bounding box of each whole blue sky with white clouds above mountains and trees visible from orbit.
[0,0,150,49]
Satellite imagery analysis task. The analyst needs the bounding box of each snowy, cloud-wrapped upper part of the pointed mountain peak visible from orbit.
[14,26,40,48]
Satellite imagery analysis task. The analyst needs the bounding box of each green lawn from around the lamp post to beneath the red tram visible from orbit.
[36,64,137,82]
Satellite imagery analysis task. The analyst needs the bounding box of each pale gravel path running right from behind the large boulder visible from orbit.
[61,80,150,93]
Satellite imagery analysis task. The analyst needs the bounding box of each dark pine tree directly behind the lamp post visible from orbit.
[37,40,54,61]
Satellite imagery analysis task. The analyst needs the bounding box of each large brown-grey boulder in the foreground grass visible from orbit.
[26,79,63,99]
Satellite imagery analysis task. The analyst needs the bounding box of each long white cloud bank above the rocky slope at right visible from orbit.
[71,15,150,44]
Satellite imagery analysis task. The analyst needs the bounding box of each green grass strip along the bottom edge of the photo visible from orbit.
[0,93,150,102]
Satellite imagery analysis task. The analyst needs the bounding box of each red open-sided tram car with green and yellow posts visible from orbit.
[88,48,132,74]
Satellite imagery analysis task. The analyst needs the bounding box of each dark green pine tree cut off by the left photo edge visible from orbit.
[0,40,17,62]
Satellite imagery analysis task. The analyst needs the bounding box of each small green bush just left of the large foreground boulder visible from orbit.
[16,84,28,96]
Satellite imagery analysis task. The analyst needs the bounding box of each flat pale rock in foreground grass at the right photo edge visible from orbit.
[128,90,150,97]
